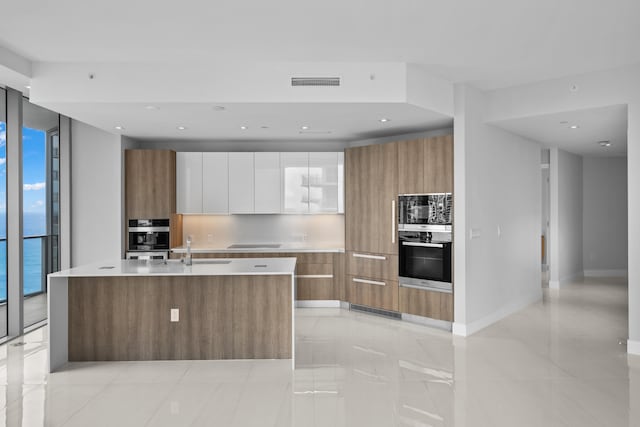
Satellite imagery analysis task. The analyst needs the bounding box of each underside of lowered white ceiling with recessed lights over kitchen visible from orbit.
[58,103,453,140]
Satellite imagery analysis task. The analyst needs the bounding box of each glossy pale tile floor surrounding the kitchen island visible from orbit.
[0,280,640,427]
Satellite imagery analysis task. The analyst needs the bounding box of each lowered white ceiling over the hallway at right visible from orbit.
[494,105,627,157]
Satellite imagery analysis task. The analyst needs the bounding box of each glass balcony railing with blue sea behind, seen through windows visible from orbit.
[0,236,49,304]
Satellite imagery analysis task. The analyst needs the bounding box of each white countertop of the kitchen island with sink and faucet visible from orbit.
[49,258,296,277]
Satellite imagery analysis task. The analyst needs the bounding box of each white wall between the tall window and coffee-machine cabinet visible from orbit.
[71,120,122,267]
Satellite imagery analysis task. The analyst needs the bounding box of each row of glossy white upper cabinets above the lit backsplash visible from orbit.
[176,152,344,215]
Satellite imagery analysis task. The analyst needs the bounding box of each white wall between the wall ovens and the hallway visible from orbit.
[453,86,542,335]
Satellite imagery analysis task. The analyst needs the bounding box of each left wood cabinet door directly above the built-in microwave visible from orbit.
[397,139,425,194]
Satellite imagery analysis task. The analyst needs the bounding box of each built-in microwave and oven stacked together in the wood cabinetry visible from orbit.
[398,193,453,293]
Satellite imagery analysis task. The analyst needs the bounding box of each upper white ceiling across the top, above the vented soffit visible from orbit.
[0,0,640,89]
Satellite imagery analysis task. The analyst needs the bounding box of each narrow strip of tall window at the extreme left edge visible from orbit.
[0,89,8,338]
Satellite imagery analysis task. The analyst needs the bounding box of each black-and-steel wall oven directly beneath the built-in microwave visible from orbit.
[399,228,453,293]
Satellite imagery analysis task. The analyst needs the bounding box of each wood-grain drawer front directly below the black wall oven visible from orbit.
[400,286,453,322]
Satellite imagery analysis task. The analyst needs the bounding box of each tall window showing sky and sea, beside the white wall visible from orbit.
[22,99,59,327]
